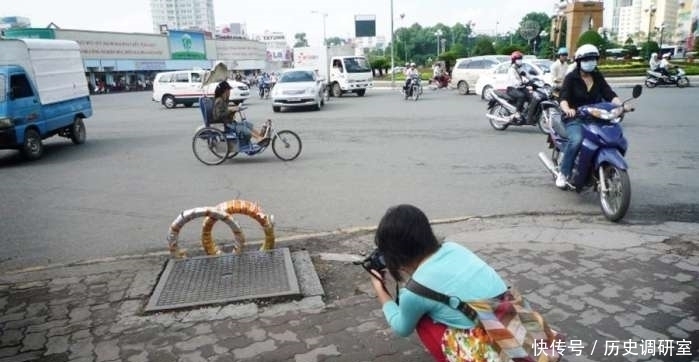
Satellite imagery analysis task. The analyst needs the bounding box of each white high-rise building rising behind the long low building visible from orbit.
[150,0,216,34]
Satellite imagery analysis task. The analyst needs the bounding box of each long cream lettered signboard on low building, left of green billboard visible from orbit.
[56,29,170,60]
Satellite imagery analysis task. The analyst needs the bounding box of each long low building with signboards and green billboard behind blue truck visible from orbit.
[0,28,267,90]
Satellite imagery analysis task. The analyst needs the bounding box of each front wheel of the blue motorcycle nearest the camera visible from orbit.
[599,164,631,222]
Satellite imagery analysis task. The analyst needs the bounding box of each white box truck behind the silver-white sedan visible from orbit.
[294,46,374,97]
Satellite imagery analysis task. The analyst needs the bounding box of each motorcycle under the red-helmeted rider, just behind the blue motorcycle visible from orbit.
[485,78,558,134]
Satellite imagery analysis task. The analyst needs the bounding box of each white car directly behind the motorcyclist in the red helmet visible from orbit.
[475,59,553,100]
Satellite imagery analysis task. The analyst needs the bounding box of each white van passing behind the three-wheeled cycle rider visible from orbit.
[153,70,250,108]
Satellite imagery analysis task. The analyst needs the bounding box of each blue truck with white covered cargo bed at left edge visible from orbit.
[0,39,92,160]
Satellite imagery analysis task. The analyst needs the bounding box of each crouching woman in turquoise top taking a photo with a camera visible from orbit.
[371,205,507,361]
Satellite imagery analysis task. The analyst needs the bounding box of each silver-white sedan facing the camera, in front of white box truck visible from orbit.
[271,69,325,112]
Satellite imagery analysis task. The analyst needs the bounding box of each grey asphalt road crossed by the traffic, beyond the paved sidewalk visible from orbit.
[0,88,699,270]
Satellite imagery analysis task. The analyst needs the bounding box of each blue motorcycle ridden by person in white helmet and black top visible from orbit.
[539,85,642,221]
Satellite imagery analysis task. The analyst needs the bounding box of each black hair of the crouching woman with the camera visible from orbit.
[374,204,440,281]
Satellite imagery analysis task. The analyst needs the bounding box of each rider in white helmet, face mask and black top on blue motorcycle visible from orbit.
[556,44,622,188]
